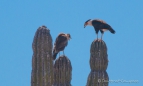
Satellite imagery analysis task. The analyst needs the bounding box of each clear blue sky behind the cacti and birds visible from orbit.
[0,0,143,86]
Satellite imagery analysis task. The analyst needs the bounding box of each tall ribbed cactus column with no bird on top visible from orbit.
[31,26,53,86]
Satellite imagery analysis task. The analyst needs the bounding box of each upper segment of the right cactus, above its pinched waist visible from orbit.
[90,40,108,70]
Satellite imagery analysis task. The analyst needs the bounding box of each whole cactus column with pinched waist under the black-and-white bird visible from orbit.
[87,40,109,86]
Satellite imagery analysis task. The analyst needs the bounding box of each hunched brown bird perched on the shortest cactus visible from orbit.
[53,33,71,60]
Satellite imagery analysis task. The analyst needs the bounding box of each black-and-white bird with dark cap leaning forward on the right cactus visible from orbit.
[84,19,115,40]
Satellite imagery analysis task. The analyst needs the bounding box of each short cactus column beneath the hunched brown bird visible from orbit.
[53,56,72,86]
